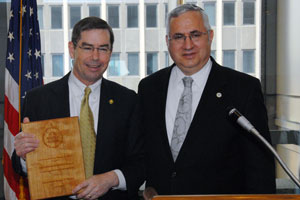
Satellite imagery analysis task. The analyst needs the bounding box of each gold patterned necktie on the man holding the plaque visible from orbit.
[79,87,96,179]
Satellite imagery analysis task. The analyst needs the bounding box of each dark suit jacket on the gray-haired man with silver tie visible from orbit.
[138,58,275,194]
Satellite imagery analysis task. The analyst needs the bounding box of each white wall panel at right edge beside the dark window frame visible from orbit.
[276,0,300,130]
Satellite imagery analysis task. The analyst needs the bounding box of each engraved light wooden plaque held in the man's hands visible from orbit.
[22,117,85,199]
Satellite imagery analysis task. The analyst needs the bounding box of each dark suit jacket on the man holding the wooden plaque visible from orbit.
[13,74,144,200]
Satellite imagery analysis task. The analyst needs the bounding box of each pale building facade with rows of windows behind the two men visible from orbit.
[38,0,261,90]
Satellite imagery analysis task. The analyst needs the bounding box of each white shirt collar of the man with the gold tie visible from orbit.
[69,70,102,96]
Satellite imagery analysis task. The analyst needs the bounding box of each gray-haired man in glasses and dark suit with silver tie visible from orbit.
[138,4,275,195]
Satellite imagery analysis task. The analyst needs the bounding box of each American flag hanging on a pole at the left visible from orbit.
[3,0,43,200]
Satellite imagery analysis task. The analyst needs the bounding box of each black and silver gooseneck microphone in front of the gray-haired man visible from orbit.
[227,107,300,188]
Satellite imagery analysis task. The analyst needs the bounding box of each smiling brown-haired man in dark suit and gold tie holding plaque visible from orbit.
[13,17,144,199]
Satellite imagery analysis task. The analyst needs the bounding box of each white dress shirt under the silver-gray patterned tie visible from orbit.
[165,59,212,144]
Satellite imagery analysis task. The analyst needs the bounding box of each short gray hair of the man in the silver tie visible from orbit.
[166,4,211,35]
